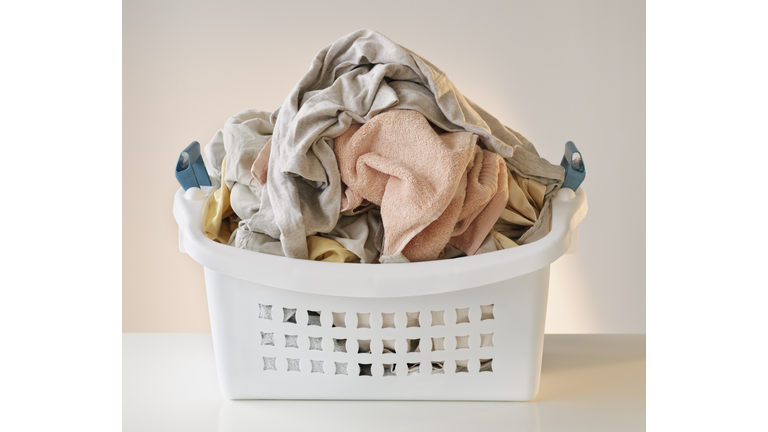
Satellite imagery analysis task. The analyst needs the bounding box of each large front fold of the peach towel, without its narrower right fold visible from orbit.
[335,110,476,261]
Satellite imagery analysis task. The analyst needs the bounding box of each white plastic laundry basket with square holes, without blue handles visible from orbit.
[173,189,587,401]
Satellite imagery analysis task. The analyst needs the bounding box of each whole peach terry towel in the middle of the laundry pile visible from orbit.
[334,110,507,262]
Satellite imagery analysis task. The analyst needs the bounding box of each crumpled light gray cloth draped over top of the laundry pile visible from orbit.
[246,29,564,259]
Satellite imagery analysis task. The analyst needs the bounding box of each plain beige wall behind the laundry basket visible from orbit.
[123,0,645,333]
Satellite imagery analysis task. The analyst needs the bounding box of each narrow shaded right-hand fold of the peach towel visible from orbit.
[450,146,509,255]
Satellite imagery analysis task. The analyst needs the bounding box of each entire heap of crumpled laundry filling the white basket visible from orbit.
[192,29,564,263]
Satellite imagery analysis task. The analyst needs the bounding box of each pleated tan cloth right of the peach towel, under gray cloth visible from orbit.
[494,173,546,240]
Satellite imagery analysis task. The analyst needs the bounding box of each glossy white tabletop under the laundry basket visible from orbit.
[123,333,645,432]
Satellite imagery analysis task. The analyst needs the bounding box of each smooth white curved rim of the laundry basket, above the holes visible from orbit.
[173,188,587,298]
